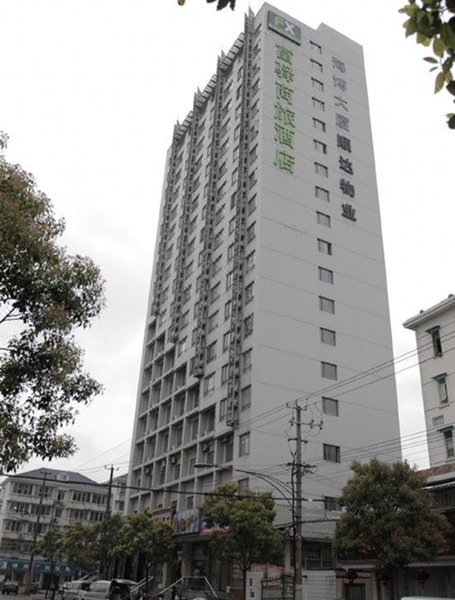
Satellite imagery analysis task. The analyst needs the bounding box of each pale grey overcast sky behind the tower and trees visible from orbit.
[0,0,455,481]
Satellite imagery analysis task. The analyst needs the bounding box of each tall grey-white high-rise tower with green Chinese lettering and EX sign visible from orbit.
[129,4,401,524]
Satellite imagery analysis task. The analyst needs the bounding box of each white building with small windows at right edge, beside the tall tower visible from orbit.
[404,294,455,467]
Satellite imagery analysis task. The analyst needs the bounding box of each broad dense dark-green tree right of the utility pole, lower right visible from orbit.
[334,459,448,569]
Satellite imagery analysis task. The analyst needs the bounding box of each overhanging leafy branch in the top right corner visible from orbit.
[400,0,455,129]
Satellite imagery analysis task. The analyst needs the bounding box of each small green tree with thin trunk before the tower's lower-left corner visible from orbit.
[116,510,176,596]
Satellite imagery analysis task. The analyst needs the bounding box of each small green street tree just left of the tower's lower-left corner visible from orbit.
[62,521,97,574]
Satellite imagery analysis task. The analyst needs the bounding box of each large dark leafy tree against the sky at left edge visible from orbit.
[0,134,104,471]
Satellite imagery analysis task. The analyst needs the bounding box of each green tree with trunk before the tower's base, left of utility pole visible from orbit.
[200,482,283,597]
